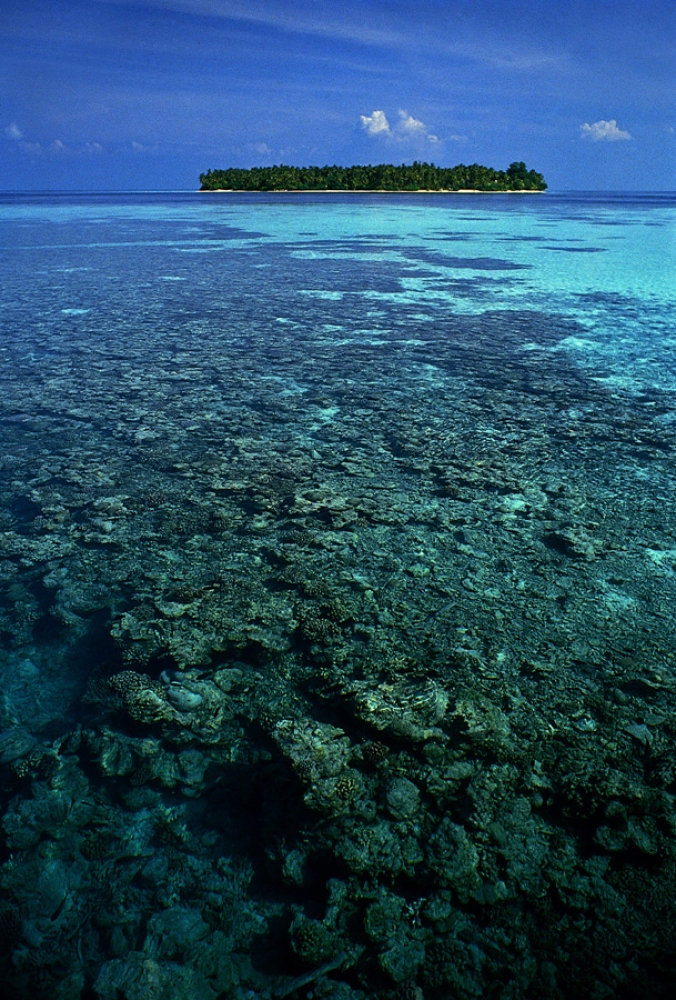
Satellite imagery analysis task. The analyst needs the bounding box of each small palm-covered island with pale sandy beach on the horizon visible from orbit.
[200,160,547,191]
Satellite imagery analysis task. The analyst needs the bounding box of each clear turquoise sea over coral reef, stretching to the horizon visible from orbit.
[0,194,676,1000]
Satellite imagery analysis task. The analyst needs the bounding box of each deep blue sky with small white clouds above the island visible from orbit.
[0,0,676,190]
